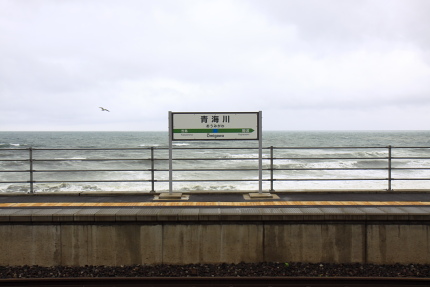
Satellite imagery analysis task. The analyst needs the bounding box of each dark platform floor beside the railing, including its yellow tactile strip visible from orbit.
[0,192,430,205]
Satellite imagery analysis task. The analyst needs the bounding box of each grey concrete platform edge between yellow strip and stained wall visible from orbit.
[0,207,430,225]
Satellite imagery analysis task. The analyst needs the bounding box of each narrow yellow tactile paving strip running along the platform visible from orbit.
[0,201,430,208]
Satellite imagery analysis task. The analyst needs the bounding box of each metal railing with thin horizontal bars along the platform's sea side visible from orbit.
[0,146,430,193]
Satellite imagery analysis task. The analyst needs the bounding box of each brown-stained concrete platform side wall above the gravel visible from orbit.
[0,220,430,266]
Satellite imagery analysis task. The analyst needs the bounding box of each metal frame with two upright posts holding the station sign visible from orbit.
[169,111,263,194]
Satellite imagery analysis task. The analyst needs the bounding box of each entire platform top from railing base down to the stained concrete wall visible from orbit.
[0,192,430,224]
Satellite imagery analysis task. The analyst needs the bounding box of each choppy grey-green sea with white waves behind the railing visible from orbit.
[0,131,430,193]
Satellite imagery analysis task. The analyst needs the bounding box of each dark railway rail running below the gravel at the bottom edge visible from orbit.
[0,277,430,287]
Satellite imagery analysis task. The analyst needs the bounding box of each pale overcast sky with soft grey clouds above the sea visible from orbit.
[0,0,430,131]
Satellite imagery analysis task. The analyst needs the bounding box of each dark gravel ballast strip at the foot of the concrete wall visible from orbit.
[0,262,430,279]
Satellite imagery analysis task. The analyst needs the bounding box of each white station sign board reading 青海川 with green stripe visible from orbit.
[170,112,260,141]
